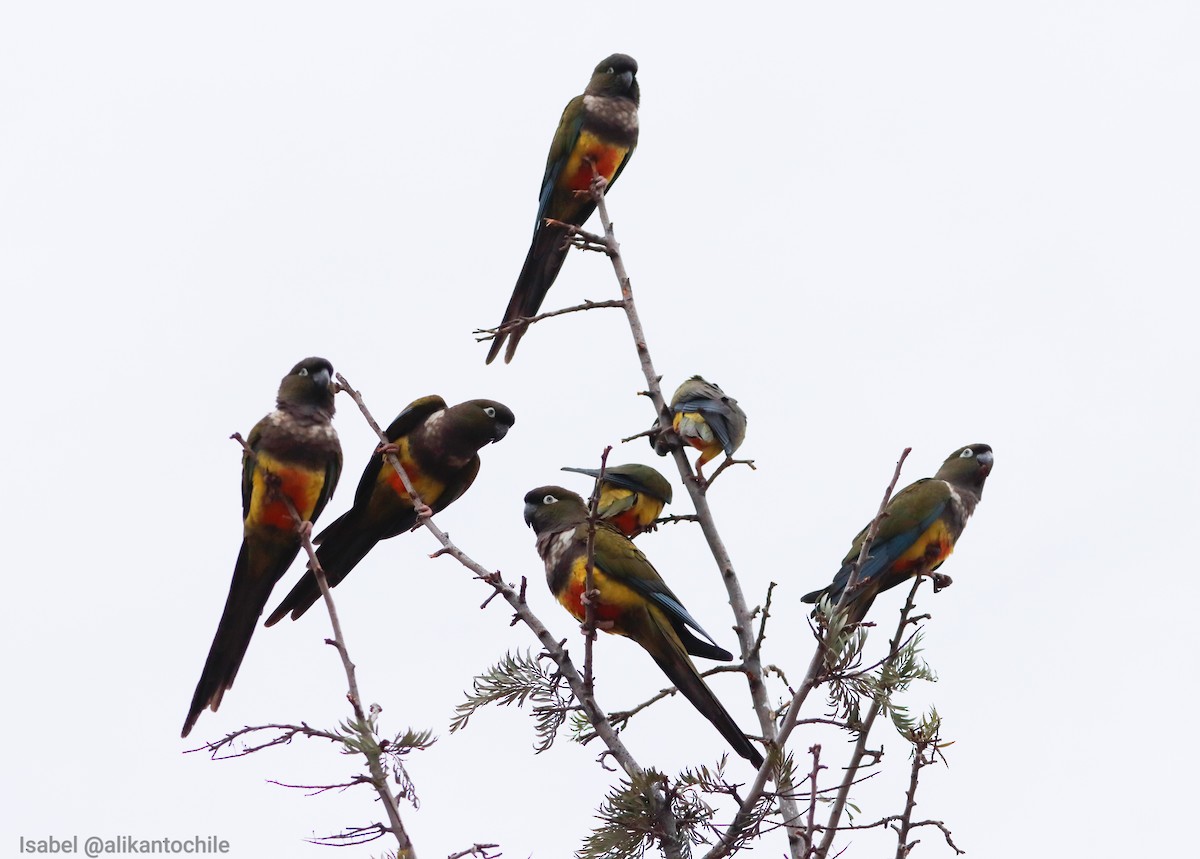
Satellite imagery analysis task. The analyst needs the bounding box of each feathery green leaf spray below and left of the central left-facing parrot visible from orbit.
[450,650,571,752]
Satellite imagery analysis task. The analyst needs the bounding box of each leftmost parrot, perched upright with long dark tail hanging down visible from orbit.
[181,358,342,737]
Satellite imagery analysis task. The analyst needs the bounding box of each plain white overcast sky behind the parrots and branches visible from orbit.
[0,2,1200,859]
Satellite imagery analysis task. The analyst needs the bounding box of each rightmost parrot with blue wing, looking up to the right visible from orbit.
[800,444,992,623]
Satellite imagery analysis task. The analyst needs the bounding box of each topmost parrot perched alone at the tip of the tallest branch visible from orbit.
[487,54,638,364]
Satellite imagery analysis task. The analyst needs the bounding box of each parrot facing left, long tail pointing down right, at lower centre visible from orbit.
[524,486,762,768]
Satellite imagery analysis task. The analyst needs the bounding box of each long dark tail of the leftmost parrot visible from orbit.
[180,540,300,737]
